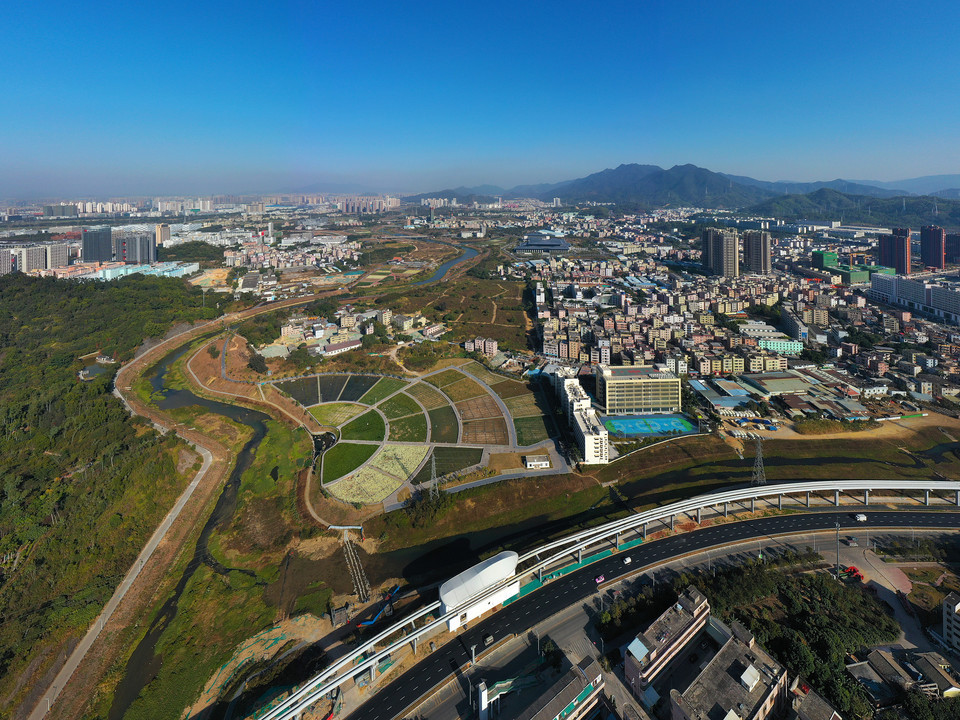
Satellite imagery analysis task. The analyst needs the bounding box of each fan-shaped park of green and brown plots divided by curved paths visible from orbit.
[274,359,552,505]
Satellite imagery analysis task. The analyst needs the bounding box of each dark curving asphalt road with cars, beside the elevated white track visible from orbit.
[347,510,960,720]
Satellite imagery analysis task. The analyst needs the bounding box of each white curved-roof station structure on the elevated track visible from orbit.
[440,550,520,630]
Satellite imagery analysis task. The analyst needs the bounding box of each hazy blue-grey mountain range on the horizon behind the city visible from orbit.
[404,163,960,222]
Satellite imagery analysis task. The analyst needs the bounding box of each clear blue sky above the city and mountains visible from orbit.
[0,0,960,197]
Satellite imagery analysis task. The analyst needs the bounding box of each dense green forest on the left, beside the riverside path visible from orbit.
[0,274,225,707]
